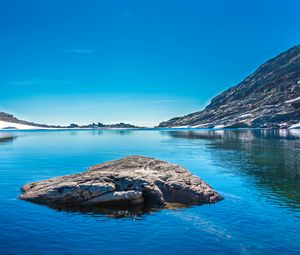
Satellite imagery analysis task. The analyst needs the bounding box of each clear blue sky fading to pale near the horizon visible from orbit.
[0,0,300,126]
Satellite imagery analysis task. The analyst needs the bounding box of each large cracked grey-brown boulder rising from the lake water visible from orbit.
[21,156,223,207]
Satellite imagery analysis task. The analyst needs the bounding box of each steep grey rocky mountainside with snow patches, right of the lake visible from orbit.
[158,46,300,128]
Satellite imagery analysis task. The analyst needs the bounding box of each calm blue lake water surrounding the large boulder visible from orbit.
[0,130,300,255]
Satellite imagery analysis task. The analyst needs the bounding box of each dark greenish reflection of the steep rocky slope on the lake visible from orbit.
[162,130,300,211]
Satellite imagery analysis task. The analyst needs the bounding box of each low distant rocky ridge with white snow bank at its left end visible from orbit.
[0,112,138,129]
